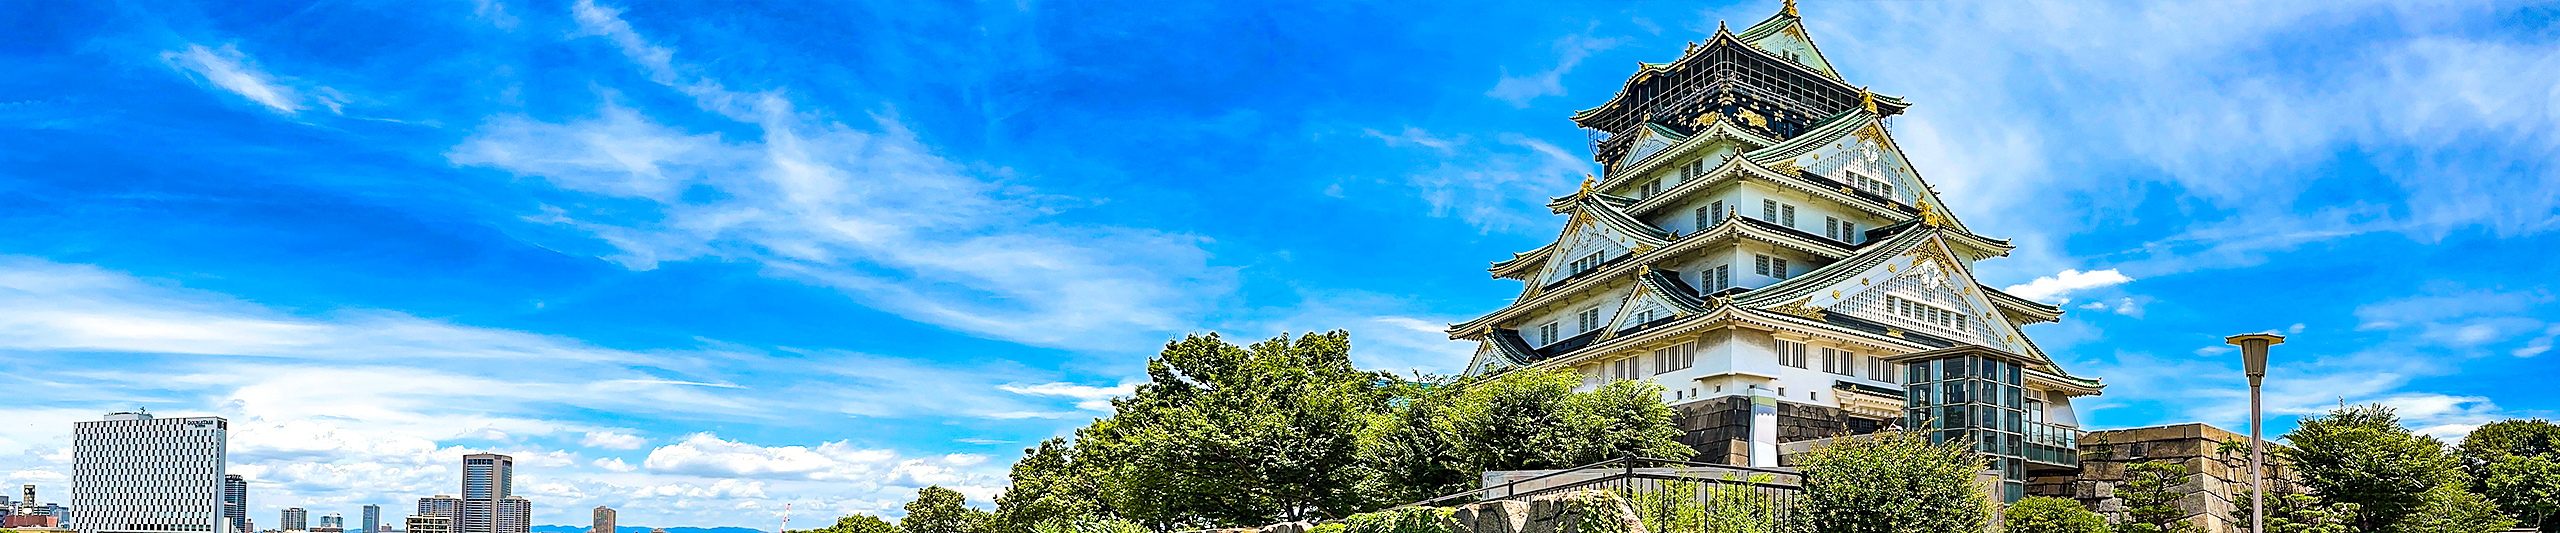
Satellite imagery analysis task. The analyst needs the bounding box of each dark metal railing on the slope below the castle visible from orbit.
[1398,456,1802,530]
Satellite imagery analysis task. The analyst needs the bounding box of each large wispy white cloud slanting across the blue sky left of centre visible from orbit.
[448,3,1234,349]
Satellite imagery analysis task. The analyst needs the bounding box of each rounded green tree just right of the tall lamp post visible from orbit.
[2276,405,2468,530]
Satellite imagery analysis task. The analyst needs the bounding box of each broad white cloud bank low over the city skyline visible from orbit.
[0,256,1085,520]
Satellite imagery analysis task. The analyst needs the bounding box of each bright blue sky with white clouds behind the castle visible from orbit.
[0,0,2560,528]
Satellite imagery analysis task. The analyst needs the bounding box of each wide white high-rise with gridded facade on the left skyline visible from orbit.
[67,413,230,533]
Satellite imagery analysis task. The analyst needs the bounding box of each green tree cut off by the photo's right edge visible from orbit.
[2460,418,2560,530]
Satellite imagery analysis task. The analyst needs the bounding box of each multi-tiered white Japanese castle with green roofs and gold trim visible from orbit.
[1449,0,2104,500]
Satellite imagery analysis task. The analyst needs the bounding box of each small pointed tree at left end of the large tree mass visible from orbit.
[988,438,1108,533]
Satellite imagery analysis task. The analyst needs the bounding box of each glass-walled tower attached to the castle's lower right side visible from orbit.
[1902,356,2028,502]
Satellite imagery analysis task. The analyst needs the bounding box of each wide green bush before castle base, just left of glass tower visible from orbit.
[1789,431,1992,533]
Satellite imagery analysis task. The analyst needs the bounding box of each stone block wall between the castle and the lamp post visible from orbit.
[2028,423,2296,533]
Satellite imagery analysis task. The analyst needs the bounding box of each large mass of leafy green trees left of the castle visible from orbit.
[998,331,1692,533]
